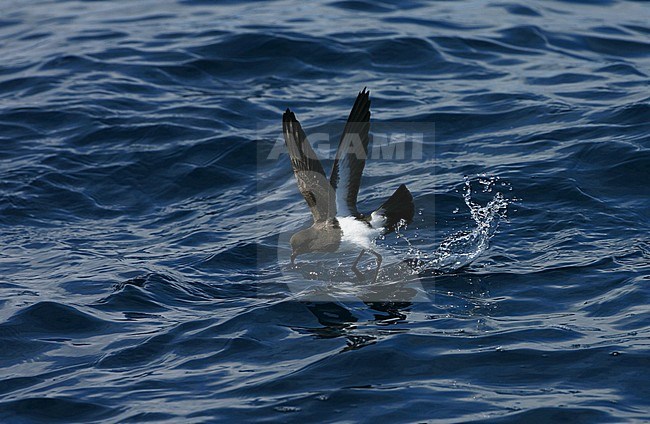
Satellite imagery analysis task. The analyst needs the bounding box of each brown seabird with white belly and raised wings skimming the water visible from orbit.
[282,88,415,281]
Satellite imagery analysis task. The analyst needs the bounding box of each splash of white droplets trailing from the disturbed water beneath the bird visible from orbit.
[290,174,511,294]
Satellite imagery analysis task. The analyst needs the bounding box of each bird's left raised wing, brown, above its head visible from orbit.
[282,109,336,222]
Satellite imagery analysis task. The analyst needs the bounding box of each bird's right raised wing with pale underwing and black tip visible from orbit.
[330,88,370,216]
